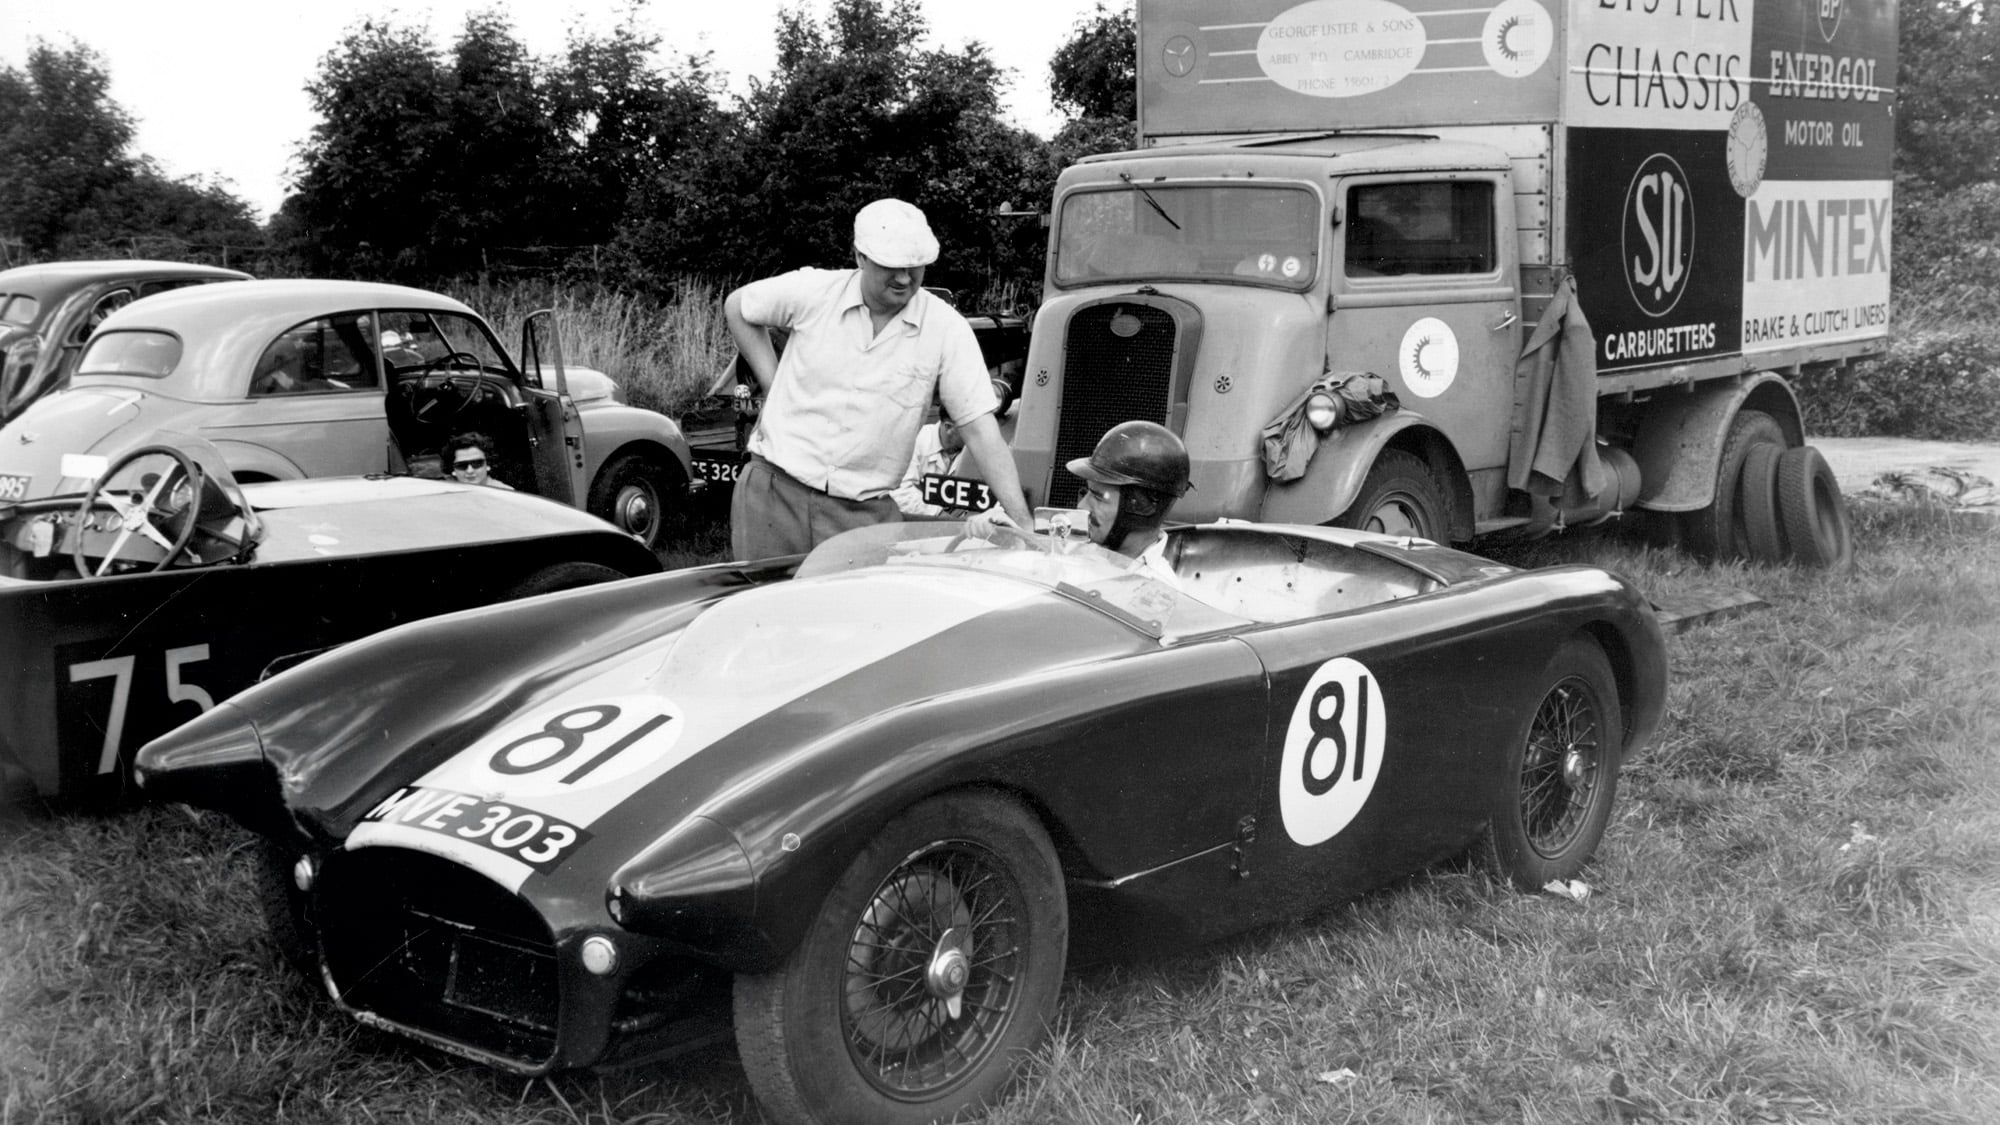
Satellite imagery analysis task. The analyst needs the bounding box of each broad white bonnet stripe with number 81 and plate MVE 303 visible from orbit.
[346,569,1150,891]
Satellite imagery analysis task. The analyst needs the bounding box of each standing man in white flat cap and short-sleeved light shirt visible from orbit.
[722,198,1034,558]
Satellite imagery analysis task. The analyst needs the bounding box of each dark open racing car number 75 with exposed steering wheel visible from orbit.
[0,434,660,799]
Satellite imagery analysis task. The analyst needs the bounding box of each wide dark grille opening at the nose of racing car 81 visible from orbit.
[316,847,560,1065]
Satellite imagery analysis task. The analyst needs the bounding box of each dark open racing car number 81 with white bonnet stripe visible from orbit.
[138,524,1666,1123]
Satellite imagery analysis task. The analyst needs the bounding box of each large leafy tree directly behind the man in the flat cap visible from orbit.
[628,0,1052,294]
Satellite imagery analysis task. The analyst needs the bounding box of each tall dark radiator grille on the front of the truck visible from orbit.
[1048,300,1178,508]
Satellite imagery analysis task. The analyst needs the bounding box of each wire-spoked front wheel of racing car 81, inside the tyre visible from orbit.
[842,841,1020,1097]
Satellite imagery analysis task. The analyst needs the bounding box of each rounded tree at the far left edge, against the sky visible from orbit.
[0,40,134,254]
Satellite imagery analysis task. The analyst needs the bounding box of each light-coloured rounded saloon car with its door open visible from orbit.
[0,280,688,546]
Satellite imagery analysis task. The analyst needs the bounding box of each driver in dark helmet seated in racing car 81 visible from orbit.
[966,422,1188,587]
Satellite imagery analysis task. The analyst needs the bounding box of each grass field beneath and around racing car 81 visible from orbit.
[0,504,2000,1125]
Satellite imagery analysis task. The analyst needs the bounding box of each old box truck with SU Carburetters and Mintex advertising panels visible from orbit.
[1014,0,1896,565]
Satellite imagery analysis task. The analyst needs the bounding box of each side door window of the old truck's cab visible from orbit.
[1346,180,1498,278]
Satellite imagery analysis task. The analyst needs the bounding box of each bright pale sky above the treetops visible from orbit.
[0,0,1130,216]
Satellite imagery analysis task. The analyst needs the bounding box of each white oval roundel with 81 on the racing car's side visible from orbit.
[1278,657,1388,847]
